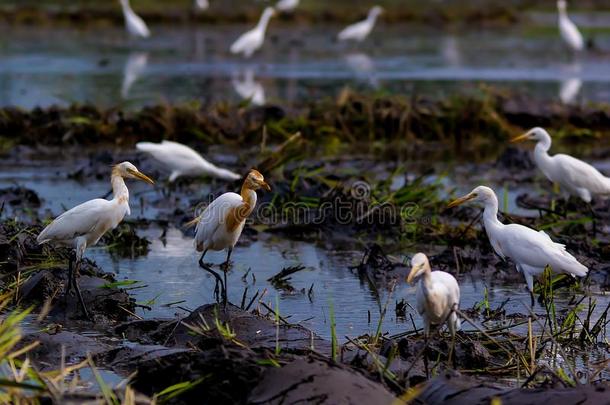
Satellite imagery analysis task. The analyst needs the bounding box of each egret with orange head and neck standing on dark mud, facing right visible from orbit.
[191,169,271,305]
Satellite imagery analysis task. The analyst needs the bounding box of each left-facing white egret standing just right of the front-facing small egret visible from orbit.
[449,186,589,306]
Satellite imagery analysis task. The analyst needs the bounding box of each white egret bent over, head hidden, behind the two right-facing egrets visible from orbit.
[136,141,241,182]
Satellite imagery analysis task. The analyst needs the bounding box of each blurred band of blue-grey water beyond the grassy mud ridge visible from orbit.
[0,16,610,108]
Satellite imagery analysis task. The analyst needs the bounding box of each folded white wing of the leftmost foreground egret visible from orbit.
[36,198,127,244]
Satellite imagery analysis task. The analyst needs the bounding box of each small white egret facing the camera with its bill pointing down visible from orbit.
[407,253,461,337]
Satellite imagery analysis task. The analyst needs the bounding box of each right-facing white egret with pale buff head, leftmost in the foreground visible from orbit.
[36,162,154,319]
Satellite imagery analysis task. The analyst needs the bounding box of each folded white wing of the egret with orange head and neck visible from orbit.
[194,193,244,252]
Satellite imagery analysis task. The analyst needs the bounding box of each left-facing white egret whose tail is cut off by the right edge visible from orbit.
[511,127,610,203]
